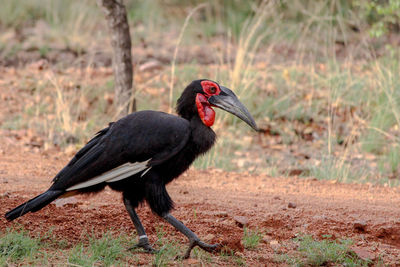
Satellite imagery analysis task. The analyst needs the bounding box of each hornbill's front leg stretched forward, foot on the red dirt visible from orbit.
[163,213,220,259]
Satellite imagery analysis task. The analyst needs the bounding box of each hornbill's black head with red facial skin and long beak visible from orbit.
[177,79,258,130]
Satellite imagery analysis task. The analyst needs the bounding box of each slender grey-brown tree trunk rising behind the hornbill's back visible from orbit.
[98,0,136,117]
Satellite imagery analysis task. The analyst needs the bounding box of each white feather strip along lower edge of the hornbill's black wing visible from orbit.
[66,159,151,191]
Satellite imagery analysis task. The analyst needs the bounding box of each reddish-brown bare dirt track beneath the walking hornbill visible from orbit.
[0,131,400,266]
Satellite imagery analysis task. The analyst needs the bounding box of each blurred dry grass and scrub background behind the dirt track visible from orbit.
[0,0,400,186]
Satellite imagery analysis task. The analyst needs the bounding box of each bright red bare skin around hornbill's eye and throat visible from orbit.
[196,81,221,127]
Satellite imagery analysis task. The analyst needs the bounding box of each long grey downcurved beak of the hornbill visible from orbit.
[208,86,258,131]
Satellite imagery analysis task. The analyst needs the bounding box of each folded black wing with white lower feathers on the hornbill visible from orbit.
[52,111,190,191]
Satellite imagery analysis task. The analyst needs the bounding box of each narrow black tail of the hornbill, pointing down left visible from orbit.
[5,190,65,221]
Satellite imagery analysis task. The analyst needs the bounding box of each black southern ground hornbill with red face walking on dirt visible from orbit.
[5,80,257,258]
